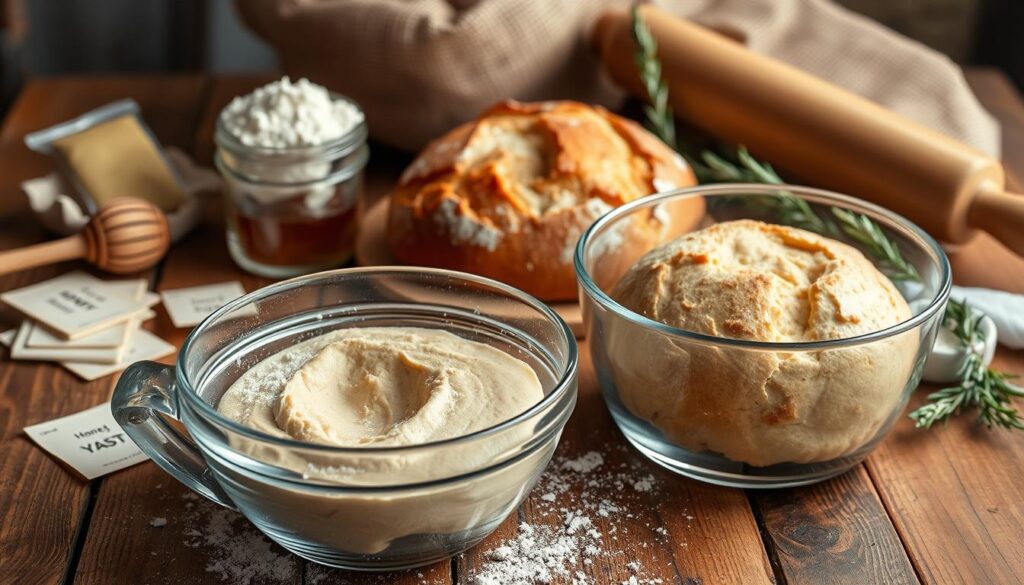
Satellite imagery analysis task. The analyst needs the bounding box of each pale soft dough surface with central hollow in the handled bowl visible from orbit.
[224,327,544,447]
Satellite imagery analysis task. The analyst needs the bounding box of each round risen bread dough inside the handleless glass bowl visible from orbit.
[605,220,918,466]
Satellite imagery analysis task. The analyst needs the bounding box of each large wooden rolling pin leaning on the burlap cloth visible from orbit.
[594,5,1024,255]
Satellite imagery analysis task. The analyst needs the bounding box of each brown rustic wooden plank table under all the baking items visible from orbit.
[0,71,1024,585]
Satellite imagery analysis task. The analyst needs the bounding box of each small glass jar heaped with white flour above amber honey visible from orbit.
[214,78,370,279]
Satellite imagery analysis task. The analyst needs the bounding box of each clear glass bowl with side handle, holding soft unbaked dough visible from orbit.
[112,267,578,570]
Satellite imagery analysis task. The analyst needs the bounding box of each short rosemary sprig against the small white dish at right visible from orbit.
[909,299,1024,429]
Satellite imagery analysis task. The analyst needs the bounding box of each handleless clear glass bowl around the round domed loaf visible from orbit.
[574,184,950,488]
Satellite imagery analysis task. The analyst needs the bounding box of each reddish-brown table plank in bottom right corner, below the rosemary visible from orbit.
[867,374,1024,584]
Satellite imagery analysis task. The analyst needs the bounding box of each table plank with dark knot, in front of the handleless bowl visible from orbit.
[752,465,919,585]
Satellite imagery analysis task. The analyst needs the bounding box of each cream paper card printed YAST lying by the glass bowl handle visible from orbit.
[25,403,146,479]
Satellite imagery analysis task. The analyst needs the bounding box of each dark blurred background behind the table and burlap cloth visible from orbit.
[0,0,1024,103]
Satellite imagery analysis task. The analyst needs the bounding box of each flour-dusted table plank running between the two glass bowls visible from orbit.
[457,350,774,585]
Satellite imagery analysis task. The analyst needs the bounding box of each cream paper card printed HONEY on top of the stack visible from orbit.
[0,271,148,338]
